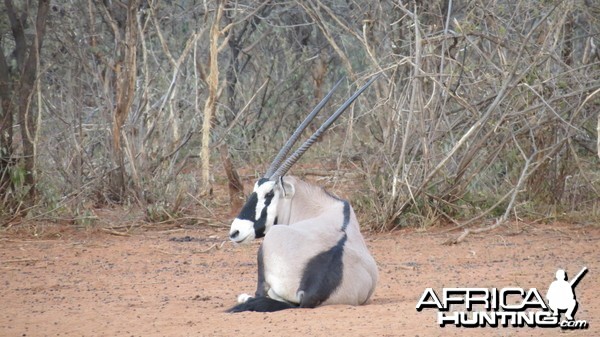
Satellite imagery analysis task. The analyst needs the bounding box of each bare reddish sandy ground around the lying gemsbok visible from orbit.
[0,220,600,336]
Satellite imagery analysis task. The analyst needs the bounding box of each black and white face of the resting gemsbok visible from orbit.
[229,178,280,243]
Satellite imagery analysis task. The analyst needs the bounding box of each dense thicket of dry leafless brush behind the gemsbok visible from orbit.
[0,0,600,230]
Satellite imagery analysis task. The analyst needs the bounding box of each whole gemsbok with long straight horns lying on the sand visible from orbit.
[228,76,377,312]
